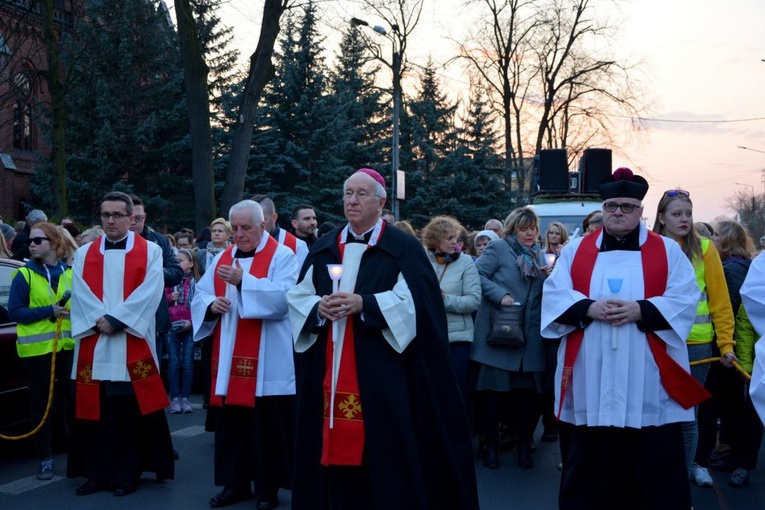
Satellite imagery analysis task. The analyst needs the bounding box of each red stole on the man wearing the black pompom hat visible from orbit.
[558,228,711,418]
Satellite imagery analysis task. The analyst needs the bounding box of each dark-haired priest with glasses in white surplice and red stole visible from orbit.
[67,192,175,496]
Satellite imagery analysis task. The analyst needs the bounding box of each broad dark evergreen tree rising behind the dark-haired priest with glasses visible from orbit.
[46,0,193,225]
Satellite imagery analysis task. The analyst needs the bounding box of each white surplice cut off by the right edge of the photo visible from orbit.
[741,252,765,423]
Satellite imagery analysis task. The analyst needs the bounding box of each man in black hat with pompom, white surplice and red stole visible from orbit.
[541,168,709,510]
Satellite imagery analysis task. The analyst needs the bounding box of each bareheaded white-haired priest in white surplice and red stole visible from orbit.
[191,200,298,509]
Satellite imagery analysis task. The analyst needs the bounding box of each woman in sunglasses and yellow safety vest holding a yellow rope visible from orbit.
[8,222,74,480]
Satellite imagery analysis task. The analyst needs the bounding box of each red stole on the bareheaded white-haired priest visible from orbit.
[210,236,279,407]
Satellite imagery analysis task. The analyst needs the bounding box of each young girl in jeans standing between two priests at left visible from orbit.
[165,248,199,414]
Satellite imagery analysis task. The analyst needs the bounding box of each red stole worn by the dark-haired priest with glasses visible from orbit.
[75,235,170,420]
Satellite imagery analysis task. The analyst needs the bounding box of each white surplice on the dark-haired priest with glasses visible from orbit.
[71,232,164,381]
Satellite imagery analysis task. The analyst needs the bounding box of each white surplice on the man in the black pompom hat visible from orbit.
[541,224,700,428]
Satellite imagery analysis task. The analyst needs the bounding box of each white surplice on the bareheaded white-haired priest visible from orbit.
[191,232,298,397]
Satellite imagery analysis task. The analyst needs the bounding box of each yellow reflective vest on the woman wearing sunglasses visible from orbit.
[13,267,74,358]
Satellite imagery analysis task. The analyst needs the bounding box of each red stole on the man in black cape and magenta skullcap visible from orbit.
[321,221,385,466]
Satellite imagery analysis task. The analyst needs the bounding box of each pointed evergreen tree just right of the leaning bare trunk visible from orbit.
[246,2,348,221]
